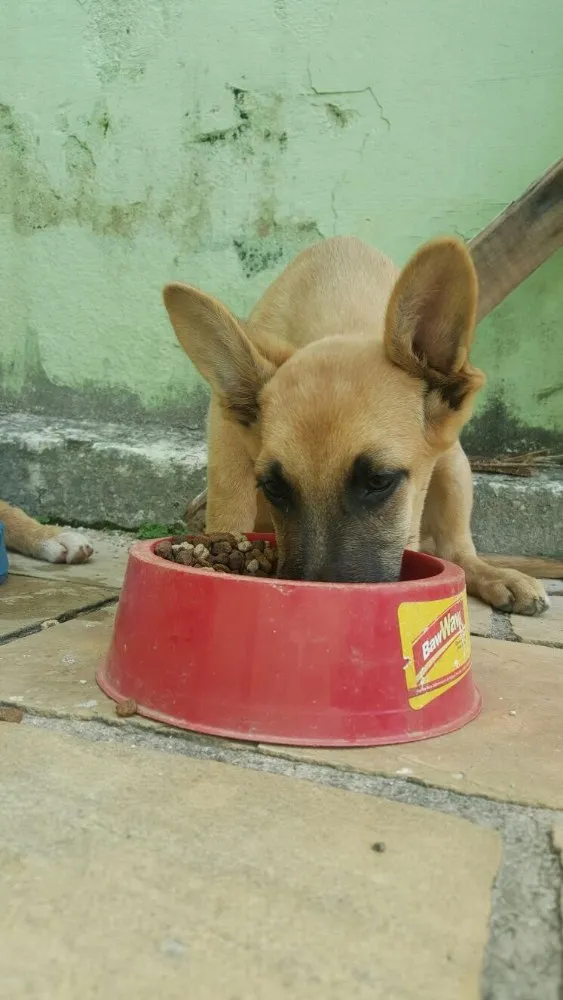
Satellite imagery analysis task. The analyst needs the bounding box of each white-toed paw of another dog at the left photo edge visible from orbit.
[0,500,94,563]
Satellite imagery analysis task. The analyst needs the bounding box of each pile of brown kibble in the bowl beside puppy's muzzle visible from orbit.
[154,533,278,577]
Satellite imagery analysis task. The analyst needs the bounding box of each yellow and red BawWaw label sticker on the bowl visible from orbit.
[398,591,471,709]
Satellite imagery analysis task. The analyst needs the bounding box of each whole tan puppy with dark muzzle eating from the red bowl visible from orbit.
[164,237,548,615]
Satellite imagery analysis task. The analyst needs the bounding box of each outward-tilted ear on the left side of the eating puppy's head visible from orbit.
[163,283,282,427]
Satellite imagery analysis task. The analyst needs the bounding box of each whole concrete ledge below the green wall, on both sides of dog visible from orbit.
[0,413,563,558]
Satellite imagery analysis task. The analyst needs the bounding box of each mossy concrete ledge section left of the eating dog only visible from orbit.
[0,413,206,528]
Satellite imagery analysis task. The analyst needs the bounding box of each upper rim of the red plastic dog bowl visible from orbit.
[129,532,465,601]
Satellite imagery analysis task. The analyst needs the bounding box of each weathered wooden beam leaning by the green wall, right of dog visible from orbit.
[469,159,563,321]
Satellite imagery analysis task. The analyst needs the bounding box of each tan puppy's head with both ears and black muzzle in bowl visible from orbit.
[164,239,484,582]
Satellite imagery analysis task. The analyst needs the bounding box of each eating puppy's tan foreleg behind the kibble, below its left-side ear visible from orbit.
[206,400,256,533]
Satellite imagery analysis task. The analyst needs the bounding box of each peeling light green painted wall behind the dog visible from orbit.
[0,0,563,450]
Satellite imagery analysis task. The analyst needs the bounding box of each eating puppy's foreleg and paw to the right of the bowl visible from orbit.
[421,444,549,615]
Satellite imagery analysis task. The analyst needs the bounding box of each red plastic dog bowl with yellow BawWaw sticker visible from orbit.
[98,535,481,746]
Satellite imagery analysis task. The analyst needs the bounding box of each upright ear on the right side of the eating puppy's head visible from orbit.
[385,238,484,411]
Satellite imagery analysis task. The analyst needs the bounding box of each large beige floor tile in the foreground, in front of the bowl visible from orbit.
[0,725,500,1000]
